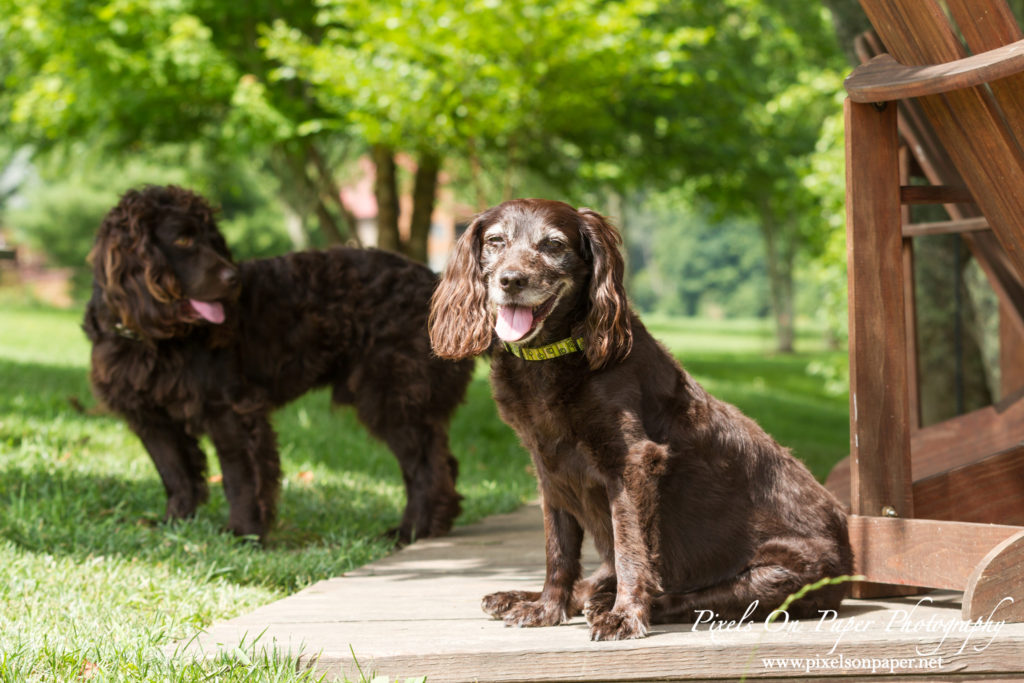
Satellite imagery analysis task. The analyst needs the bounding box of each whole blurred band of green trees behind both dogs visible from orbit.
[0,0,849,350]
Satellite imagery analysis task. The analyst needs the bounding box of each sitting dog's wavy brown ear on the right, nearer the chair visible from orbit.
[579,209,633,370]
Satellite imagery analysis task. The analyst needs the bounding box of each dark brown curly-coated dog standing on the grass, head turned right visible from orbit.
[84,186,472,543]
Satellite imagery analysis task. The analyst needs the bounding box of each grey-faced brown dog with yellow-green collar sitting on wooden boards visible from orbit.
[431,200,852,640]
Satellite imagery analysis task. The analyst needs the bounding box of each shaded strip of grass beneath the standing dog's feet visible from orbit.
[0,468,397,591]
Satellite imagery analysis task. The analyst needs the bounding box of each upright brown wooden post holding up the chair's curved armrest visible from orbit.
[845,99,913,597]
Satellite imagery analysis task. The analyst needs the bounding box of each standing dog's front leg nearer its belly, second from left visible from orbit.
[207,411,281,541]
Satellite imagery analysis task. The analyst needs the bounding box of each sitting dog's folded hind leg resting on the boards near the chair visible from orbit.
[651,539,846,624]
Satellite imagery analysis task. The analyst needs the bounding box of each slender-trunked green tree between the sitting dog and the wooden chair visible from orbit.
[655,5,846,351]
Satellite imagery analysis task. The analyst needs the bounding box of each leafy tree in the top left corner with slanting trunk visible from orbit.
[0,0,356,249]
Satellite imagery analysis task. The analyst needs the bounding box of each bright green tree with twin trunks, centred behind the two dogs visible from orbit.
[263,0,702,255]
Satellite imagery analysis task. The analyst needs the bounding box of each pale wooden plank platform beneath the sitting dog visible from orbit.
[191,505,1024,683]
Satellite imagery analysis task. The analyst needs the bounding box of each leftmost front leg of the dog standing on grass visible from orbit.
[128,414,210,520]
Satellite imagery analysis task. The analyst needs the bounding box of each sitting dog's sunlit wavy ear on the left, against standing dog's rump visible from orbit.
[428,216,494,359]
